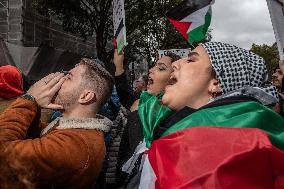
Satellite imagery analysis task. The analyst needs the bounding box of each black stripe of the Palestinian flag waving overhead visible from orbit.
[166,0,212,21]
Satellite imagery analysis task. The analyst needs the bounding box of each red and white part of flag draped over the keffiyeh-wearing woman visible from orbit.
[139,126,284,189]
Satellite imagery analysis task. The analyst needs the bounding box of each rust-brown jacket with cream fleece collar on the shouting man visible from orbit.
[0,98,112,189]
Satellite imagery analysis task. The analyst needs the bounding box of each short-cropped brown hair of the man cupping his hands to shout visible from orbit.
[77,58,114,106]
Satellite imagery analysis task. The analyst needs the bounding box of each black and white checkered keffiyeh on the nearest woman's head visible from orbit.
[202,42,278,105]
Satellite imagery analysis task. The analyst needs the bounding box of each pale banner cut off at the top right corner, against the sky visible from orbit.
[266,0,284,60]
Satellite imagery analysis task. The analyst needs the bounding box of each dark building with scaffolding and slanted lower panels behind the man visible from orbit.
[0,0,96,81]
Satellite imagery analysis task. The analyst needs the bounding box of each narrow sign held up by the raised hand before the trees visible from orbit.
[112,0,127,54]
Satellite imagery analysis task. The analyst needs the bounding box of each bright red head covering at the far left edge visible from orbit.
[0,65,24,99]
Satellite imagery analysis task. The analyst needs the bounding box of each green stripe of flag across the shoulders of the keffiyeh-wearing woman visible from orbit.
[163,101,284,149]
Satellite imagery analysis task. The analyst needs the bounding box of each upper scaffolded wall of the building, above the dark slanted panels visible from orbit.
[0,0,95,57]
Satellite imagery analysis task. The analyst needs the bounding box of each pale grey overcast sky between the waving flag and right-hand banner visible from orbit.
[210,0,275,49]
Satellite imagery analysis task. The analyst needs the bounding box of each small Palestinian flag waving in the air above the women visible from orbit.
[166,0,214,44]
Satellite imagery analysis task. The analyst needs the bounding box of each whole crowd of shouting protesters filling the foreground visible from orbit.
[0,42,284,189]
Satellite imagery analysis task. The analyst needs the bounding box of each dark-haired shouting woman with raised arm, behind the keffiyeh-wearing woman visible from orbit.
[113,49,180,187]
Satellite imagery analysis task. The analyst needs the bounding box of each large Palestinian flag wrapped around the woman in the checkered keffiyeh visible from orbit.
[138,93,284,189]
